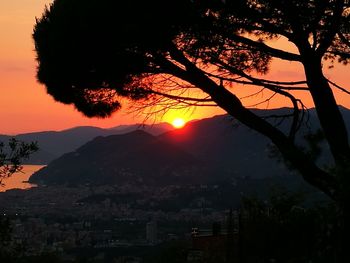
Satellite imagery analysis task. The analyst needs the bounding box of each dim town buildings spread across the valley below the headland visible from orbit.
[0,185,235,260]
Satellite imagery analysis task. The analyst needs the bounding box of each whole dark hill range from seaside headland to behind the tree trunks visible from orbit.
[28,108,350,184]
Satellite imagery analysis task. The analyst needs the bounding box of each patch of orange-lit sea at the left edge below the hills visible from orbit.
[0,165,45,192]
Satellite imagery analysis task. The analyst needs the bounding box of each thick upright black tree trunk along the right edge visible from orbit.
[303,52,350,263]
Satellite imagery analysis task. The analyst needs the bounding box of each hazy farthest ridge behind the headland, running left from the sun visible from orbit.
[0,123,173,164]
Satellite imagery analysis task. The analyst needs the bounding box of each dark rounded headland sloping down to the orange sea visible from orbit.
[30,130,204,185]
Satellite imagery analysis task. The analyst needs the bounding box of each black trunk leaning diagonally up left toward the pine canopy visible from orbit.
[182,65,336,199]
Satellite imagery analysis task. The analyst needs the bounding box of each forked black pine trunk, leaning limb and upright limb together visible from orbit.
[172,43,350,263]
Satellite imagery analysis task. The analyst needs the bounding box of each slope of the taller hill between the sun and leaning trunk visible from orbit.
[161,112,290,178]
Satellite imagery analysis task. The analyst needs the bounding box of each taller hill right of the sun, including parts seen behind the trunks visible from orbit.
[160,107,350,174]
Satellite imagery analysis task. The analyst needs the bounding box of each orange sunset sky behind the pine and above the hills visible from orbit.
[0,0,350,134]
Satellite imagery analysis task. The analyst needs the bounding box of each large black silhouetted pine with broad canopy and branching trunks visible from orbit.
[33,0,350,260]
